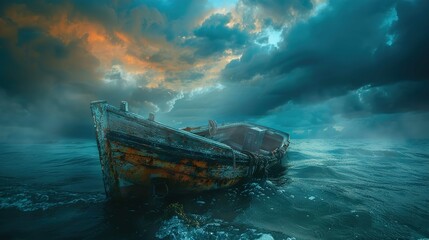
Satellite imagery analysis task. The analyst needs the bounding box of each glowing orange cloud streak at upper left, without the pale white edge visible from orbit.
[0,5,190,87]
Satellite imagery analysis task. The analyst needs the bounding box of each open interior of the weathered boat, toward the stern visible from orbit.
[184,121,287,155]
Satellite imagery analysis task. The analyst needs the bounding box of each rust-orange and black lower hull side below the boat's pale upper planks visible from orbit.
[109,134,249,195]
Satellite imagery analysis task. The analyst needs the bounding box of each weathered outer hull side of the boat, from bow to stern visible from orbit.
[91,101,288,198]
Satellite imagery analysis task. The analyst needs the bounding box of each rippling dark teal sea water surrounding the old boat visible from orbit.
[0,139,429,239]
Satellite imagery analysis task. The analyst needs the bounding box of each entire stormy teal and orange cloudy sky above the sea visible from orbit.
[0,0,429,141]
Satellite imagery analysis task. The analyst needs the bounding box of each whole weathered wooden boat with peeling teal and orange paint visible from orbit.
[91,101,289,198]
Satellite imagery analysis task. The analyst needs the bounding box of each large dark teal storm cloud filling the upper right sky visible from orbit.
[223,1,429,114]
